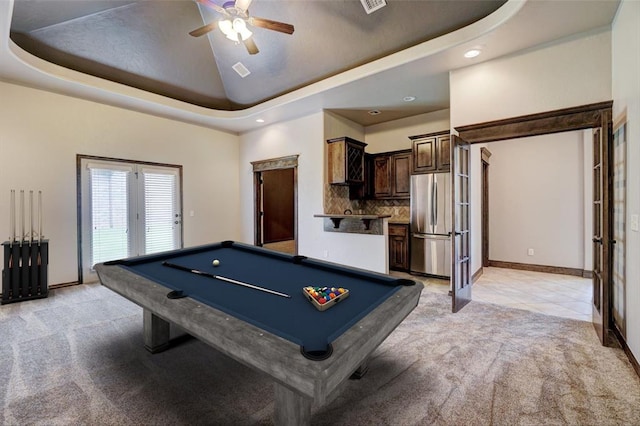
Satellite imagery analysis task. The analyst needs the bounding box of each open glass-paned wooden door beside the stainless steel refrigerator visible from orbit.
[451,135,471,312]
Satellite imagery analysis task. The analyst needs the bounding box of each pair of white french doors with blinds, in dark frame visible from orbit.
[80,157,182,282]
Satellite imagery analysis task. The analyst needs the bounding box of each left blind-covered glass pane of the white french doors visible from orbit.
[90,168,129,266]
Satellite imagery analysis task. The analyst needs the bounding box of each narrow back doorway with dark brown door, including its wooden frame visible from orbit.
[252,156,298,254]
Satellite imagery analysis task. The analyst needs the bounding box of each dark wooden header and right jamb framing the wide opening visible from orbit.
[455,101,615,346]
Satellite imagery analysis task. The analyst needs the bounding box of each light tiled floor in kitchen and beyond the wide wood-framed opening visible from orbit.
[394,267,591,321]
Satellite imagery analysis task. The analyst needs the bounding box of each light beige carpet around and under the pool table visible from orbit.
[0,285,640,425]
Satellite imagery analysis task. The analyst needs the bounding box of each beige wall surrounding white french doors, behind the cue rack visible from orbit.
[0,83,240,284]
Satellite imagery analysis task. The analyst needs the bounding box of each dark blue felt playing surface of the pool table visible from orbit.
[118,244,400,351]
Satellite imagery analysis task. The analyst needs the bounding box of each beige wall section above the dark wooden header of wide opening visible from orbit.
[450,31,611,127]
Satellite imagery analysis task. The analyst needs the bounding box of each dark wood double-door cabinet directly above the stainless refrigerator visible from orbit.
[409,130,451,174]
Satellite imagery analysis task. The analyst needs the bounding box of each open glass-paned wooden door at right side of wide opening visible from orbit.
[592,127,611,346]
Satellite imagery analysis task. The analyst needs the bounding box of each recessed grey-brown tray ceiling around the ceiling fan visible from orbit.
[10,0,505,111]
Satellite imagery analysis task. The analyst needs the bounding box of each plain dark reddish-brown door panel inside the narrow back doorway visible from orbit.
[261,168,295,244]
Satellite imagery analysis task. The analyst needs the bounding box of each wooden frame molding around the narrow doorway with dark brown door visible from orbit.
[251,154,300,253]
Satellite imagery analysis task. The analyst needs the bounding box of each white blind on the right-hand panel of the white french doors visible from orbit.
[142,169,179,253]
